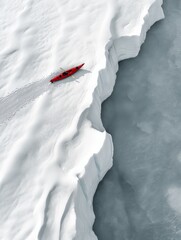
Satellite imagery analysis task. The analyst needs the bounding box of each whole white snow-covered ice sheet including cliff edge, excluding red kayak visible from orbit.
[0,0,163,240]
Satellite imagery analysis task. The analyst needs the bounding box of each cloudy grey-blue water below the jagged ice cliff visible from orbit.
[93,0,181,240]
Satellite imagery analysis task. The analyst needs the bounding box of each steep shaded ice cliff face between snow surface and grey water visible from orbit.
[73,0,164,240]
